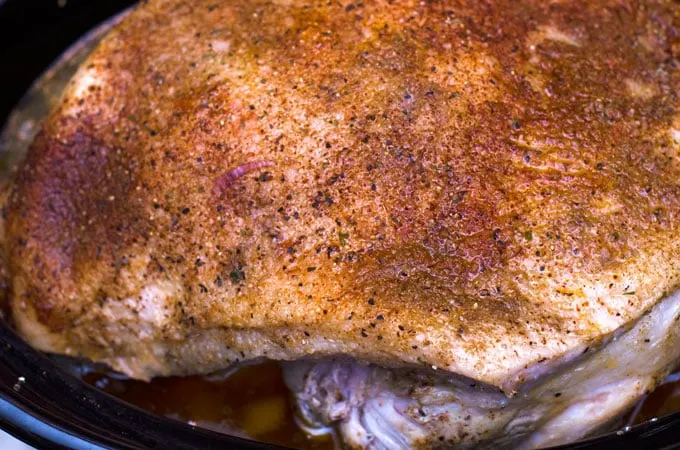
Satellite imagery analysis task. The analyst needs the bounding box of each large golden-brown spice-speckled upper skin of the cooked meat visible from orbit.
[5,0,680,392]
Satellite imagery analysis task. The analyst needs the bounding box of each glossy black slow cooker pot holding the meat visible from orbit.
[0,0,680,450]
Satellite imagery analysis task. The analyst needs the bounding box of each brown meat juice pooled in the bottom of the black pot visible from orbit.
[84,361,680,450]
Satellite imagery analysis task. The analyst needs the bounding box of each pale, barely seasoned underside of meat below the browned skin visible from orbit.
[284,292,680,450]
